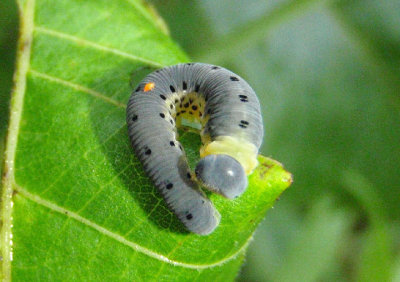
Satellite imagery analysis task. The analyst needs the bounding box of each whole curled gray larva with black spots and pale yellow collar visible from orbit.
[127,63,263,235]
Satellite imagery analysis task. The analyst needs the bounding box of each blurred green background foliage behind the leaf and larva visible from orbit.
[0,0,400,281]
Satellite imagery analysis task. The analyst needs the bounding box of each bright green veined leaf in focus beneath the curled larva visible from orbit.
[1,0,291,281]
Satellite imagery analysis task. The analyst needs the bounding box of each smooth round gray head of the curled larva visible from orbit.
[195,154,247,199]
